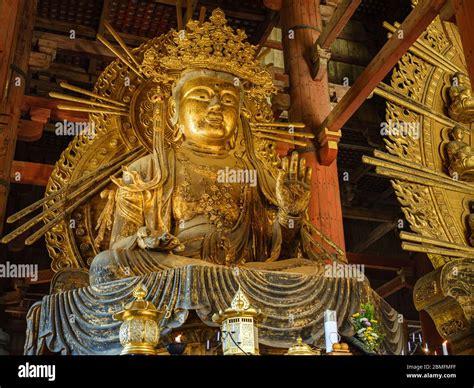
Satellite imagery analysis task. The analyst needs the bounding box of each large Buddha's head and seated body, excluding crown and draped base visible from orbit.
[90,69,314,284]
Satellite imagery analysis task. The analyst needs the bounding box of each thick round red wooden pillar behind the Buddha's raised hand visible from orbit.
[280,0,344,249]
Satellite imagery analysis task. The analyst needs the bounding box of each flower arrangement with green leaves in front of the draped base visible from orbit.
[351,303,385,352]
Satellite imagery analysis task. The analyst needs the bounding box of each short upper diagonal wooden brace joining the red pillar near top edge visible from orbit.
[315,0,361,49]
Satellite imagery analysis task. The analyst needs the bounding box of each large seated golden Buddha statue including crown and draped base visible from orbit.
[17,9,405,354]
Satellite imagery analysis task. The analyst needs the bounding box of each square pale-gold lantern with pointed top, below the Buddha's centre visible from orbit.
[212,287,260,356]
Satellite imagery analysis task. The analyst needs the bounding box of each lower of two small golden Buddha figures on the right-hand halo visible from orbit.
[446,126,474,182]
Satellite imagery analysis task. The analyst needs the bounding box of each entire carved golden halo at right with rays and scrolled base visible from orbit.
[364,14,474,354]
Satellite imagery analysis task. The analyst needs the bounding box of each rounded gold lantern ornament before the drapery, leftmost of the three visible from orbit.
[113,285,165,355]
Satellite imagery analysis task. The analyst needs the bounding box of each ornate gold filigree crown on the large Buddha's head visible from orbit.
[141,8,275,97]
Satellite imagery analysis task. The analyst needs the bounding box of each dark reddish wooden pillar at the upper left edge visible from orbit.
[0,0,36,234]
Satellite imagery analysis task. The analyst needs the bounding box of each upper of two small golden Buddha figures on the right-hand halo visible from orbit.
[448,72,474,123]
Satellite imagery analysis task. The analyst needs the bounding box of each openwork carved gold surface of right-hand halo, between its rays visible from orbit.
[378,18,472,268]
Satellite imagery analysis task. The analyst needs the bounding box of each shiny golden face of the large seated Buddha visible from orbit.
[178,76,240,148]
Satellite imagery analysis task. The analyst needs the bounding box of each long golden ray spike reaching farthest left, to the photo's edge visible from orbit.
[1,149,145,243]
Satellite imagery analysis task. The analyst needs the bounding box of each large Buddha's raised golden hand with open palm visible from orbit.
[276,151,312,217]
